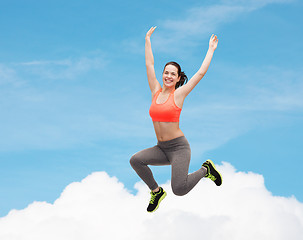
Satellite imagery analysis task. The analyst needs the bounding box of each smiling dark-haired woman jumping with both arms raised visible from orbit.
[130,27,222,212]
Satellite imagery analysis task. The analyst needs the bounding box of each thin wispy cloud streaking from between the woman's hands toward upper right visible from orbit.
[150,0,293,54]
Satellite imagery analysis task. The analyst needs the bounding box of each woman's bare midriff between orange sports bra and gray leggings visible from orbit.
[153,122,184,141]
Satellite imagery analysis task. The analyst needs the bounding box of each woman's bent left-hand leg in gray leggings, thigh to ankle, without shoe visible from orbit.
[130,145,170,190]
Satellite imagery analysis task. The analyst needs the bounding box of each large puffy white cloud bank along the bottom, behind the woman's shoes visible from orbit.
[0,163,303,240]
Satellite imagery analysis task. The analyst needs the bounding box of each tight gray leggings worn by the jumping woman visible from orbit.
[130,136,206,196]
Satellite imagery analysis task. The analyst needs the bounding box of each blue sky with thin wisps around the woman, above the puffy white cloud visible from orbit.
[0,0,303,216]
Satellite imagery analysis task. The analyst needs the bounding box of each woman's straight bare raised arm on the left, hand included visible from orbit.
[145,27,161,96]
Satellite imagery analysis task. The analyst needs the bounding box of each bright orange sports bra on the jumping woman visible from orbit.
[149,89,182,122]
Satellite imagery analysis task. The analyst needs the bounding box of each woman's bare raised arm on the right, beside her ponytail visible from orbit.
[178,34,218,98]
